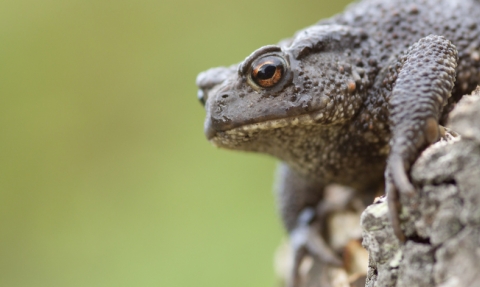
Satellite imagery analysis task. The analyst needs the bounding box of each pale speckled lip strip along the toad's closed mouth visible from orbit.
[205,109,339,146]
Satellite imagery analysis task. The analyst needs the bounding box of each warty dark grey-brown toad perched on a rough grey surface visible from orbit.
[197,0,480,285]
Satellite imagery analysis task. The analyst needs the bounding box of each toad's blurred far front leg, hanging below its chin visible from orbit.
[277,165,349,287]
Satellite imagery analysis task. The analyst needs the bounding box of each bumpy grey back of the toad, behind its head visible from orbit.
[328,0,480,99]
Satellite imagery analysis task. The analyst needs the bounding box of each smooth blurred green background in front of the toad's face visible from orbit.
[0,0,349,287]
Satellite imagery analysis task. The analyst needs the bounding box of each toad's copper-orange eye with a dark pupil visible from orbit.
[250,56,285,88]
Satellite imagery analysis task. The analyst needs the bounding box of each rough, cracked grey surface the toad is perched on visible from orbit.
[361,88,480,287]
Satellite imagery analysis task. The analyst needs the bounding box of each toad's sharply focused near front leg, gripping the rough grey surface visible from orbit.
[385,35,457,241]
